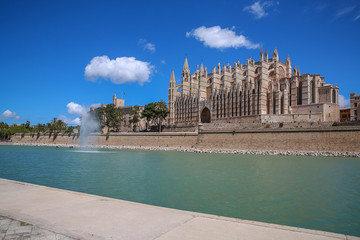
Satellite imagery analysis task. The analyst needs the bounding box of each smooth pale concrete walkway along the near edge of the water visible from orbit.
[0,179,360,240]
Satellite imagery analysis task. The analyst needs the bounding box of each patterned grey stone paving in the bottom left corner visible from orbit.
[0,216,74,240]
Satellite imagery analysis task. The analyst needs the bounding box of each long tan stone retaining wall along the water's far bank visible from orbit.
[12,127,360,152]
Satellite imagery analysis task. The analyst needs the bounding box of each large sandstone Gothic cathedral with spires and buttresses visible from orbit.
[168,49,340,125]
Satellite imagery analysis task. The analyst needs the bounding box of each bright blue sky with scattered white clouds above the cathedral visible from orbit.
[0,0,360,124]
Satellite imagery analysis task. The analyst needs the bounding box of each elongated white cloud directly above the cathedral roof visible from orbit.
[186,26,260,49]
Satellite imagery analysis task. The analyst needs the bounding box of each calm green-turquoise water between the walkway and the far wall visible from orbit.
[0,146,360,236]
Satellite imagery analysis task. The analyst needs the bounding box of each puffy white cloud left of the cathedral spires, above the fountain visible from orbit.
[85,56,154,85]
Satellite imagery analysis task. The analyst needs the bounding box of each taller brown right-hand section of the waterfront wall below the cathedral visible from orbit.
[196,128,360,152]
